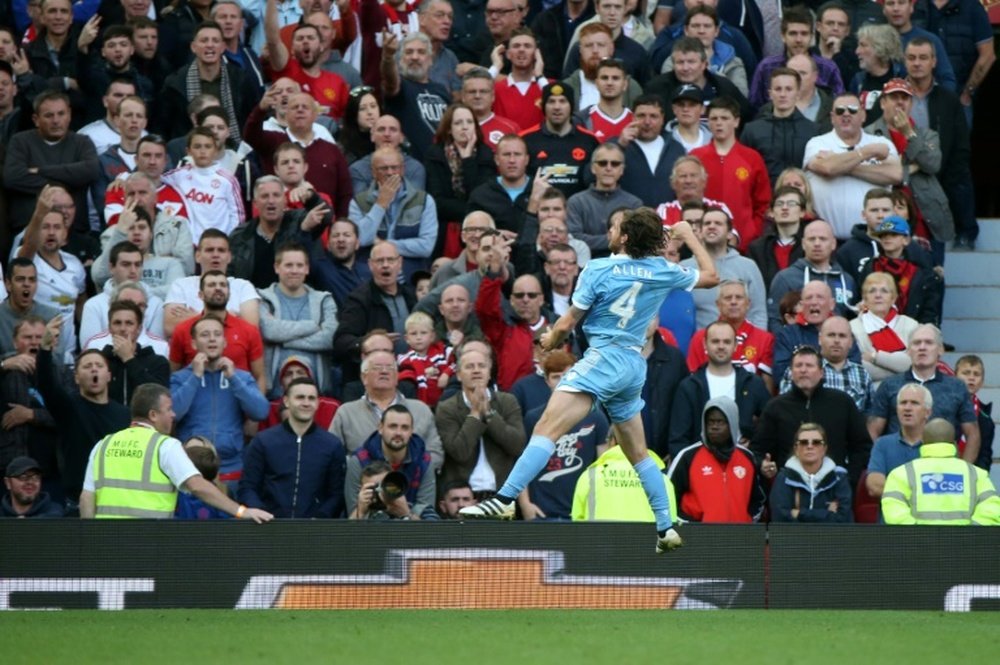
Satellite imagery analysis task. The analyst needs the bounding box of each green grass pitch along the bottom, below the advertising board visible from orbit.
[0,610,1000,665]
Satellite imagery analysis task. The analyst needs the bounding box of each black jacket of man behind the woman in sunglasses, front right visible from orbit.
[750,384,872,488]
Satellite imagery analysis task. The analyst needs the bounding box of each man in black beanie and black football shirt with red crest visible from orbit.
[523,83,600,198]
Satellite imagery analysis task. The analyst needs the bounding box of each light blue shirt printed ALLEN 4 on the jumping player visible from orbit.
[573,254,699,349]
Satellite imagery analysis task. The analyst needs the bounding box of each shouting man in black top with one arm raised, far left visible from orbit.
[35,316,129,508]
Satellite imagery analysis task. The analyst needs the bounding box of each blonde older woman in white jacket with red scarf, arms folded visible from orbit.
[851,272,919,383]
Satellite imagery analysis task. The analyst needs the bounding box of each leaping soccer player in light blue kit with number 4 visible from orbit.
[459,208,719,553]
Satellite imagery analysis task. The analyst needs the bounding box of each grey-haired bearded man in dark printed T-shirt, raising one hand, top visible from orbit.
[380,32,451,160]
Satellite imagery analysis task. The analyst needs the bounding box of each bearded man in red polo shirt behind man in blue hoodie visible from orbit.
[170,270,267,394]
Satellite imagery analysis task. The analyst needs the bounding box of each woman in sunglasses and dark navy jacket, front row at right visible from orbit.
[762,423,854,522]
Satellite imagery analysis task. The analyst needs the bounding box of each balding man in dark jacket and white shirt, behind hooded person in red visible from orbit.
[668,321,771,456]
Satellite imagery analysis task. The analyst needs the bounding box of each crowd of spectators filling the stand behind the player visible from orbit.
[0,0,995,522]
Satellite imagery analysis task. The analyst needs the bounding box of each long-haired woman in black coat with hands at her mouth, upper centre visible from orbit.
[425,104,496,258]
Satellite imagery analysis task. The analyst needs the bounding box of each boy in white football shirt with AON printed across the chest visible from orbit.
[163,127,244,245]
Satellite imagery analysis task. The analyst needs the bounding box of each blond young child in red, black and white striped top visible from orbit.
[396,312,455,407]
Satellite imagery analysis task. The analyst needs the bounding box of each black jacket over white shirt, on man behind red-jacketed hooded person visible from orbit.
[668,366,771,457]
